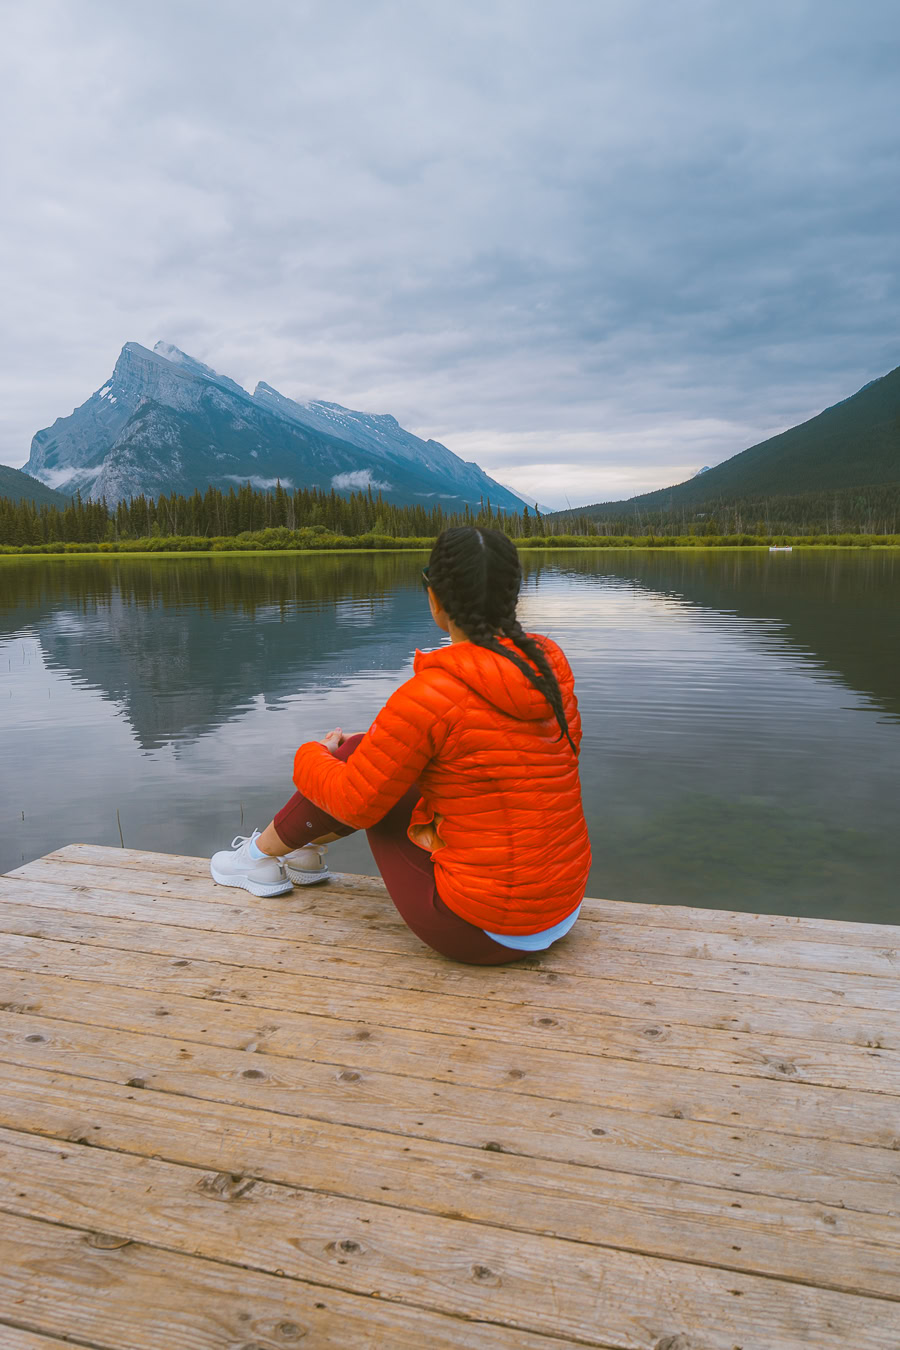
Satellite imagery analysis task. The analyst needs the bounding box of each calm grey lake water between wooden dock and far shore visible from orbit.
[0,551,900,922]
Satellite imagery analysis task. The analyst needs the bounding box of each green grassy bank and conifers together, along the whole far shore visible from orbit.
[0,483,900,558]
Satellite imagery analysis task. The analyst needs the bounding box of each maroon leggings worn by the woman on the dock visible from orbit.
[273,734,532,965]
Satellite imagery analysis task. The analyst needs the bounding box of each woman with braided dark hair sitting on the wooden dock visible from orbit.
[210,527,591,965]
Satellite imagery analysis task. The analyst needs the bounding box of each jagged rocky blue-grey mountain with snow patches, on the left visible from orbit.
[26,343,519,510]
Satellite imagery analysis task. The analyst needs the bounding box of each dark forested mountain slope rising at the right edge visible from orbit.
[569,366,900,517]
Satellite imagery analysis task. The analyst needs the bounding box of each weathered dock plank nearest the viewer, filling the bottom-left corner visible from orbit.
[0,1214,585,1350]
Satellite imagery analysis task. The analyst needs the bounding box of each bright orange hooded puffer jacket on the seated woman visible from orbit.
[294,633,591,934]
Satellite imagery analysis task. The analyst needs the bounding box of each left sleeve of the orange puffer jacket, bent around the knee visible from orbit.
[294,675,456,830]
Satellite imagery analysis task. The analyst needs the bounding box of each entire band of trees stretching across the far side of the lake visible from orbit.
[0,485,900,554]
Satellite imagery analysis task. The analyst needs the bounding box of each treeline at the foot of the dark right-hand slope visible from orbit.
[544,483,900,536]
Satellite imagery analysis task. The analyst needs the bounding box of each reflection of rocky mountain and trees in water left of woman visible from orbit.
[0,554,430,749]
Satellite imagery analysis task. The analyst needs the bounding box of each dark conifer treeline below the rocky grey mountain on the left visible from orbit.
[0,483,544,547]
